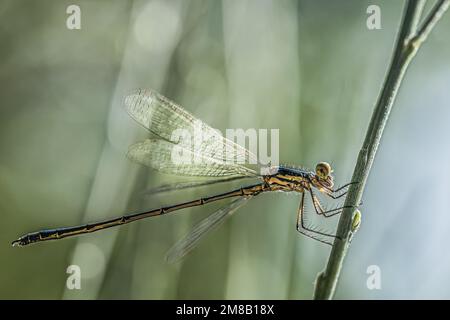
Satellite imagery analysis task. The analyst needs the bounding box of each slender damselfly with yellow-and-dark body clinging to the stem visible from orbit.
[13,90,351,261]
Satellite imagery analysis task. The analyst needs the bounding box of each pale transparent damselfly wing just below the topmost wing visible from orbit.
[127,139,256,177]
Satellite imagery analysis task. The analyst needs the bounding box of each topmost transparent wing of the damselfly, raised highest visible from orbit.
[125,89,258,164]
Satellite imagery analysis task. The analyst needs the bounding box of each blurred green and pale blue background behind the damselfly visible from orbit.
[0,0,450,299]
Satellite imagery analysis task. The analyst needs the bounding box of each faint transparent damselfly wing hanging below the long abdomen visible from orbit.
[166,198,250,263]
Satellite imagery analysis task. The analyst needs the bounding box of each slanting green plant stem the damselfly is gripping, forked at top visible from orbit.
[314,0,450,299]
